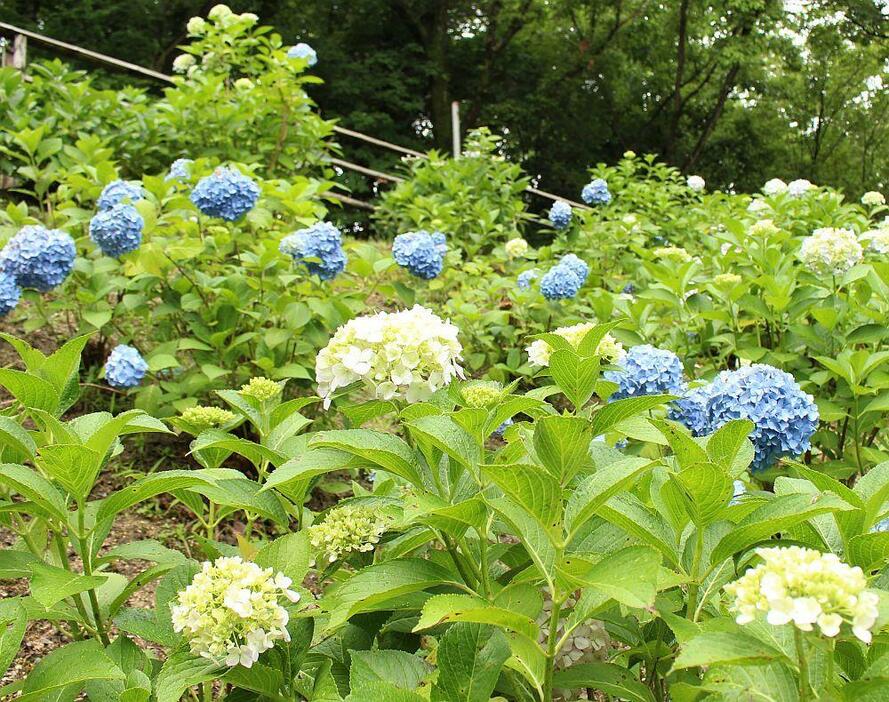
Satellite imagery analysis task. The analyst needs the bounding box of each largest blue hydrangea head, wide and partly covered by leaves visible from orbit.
[671,363,818,473]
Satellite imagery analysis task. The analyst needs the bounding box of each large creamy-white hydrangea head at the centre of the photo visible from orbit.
[315,305,463,407]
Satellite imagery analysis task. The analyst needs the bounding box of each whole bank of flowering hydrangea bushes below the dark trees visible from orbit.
[0,6,889,702]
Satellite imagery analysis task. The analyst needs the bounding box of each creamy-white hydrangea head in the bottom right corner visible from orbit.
[725,546,880,643]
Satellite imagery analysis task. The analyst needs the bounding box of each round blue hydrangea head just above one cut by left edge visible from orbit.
[0,224,77,292]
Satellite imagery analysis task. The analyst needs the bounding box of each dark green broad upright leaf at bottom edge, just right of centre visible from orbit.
[432,623,510,702]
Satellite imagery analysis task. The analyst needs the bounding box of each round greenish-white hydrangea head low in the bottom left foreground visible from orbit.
[171,556,299,668]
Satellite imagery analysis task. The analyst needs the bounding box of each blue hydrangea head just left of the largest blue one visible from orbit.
[604,344,686,400]
